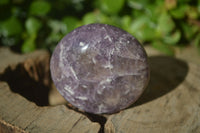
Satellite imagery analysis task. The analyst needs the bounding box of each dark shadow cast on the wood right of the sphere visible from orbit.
[132,56,188,107]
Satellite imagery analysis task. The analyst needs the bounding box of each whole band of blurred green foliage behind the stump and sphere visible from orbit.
[0,0,200,55]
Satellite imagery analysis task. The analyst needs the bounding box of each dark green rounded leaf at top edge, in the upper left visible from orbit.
[30,0,51,16]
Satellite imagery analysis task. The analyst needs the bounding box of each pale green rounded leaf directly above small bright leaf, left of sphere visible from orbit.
[25,17,42,35]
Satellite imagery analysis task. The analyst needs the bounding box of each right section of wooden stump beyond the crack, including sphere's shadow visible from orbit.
[105,46,200,133]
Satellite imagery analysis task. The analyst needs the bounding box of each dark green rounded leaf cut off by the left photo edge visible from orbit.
[0,17,22,37]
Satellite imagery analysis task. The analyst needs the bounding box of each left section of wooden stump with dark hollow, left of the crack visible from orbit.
[0,48,100,133]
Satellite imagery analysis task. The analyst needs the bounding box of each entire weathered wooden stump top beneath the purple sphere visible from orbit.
[0,47,200,133]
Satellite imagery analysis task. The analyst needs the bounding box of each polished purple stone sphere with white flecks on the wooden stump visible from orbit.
[50,24,149,114]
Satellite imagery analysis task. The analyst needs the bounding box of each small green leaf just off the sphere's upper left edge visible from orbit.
[62,16,78,32]
